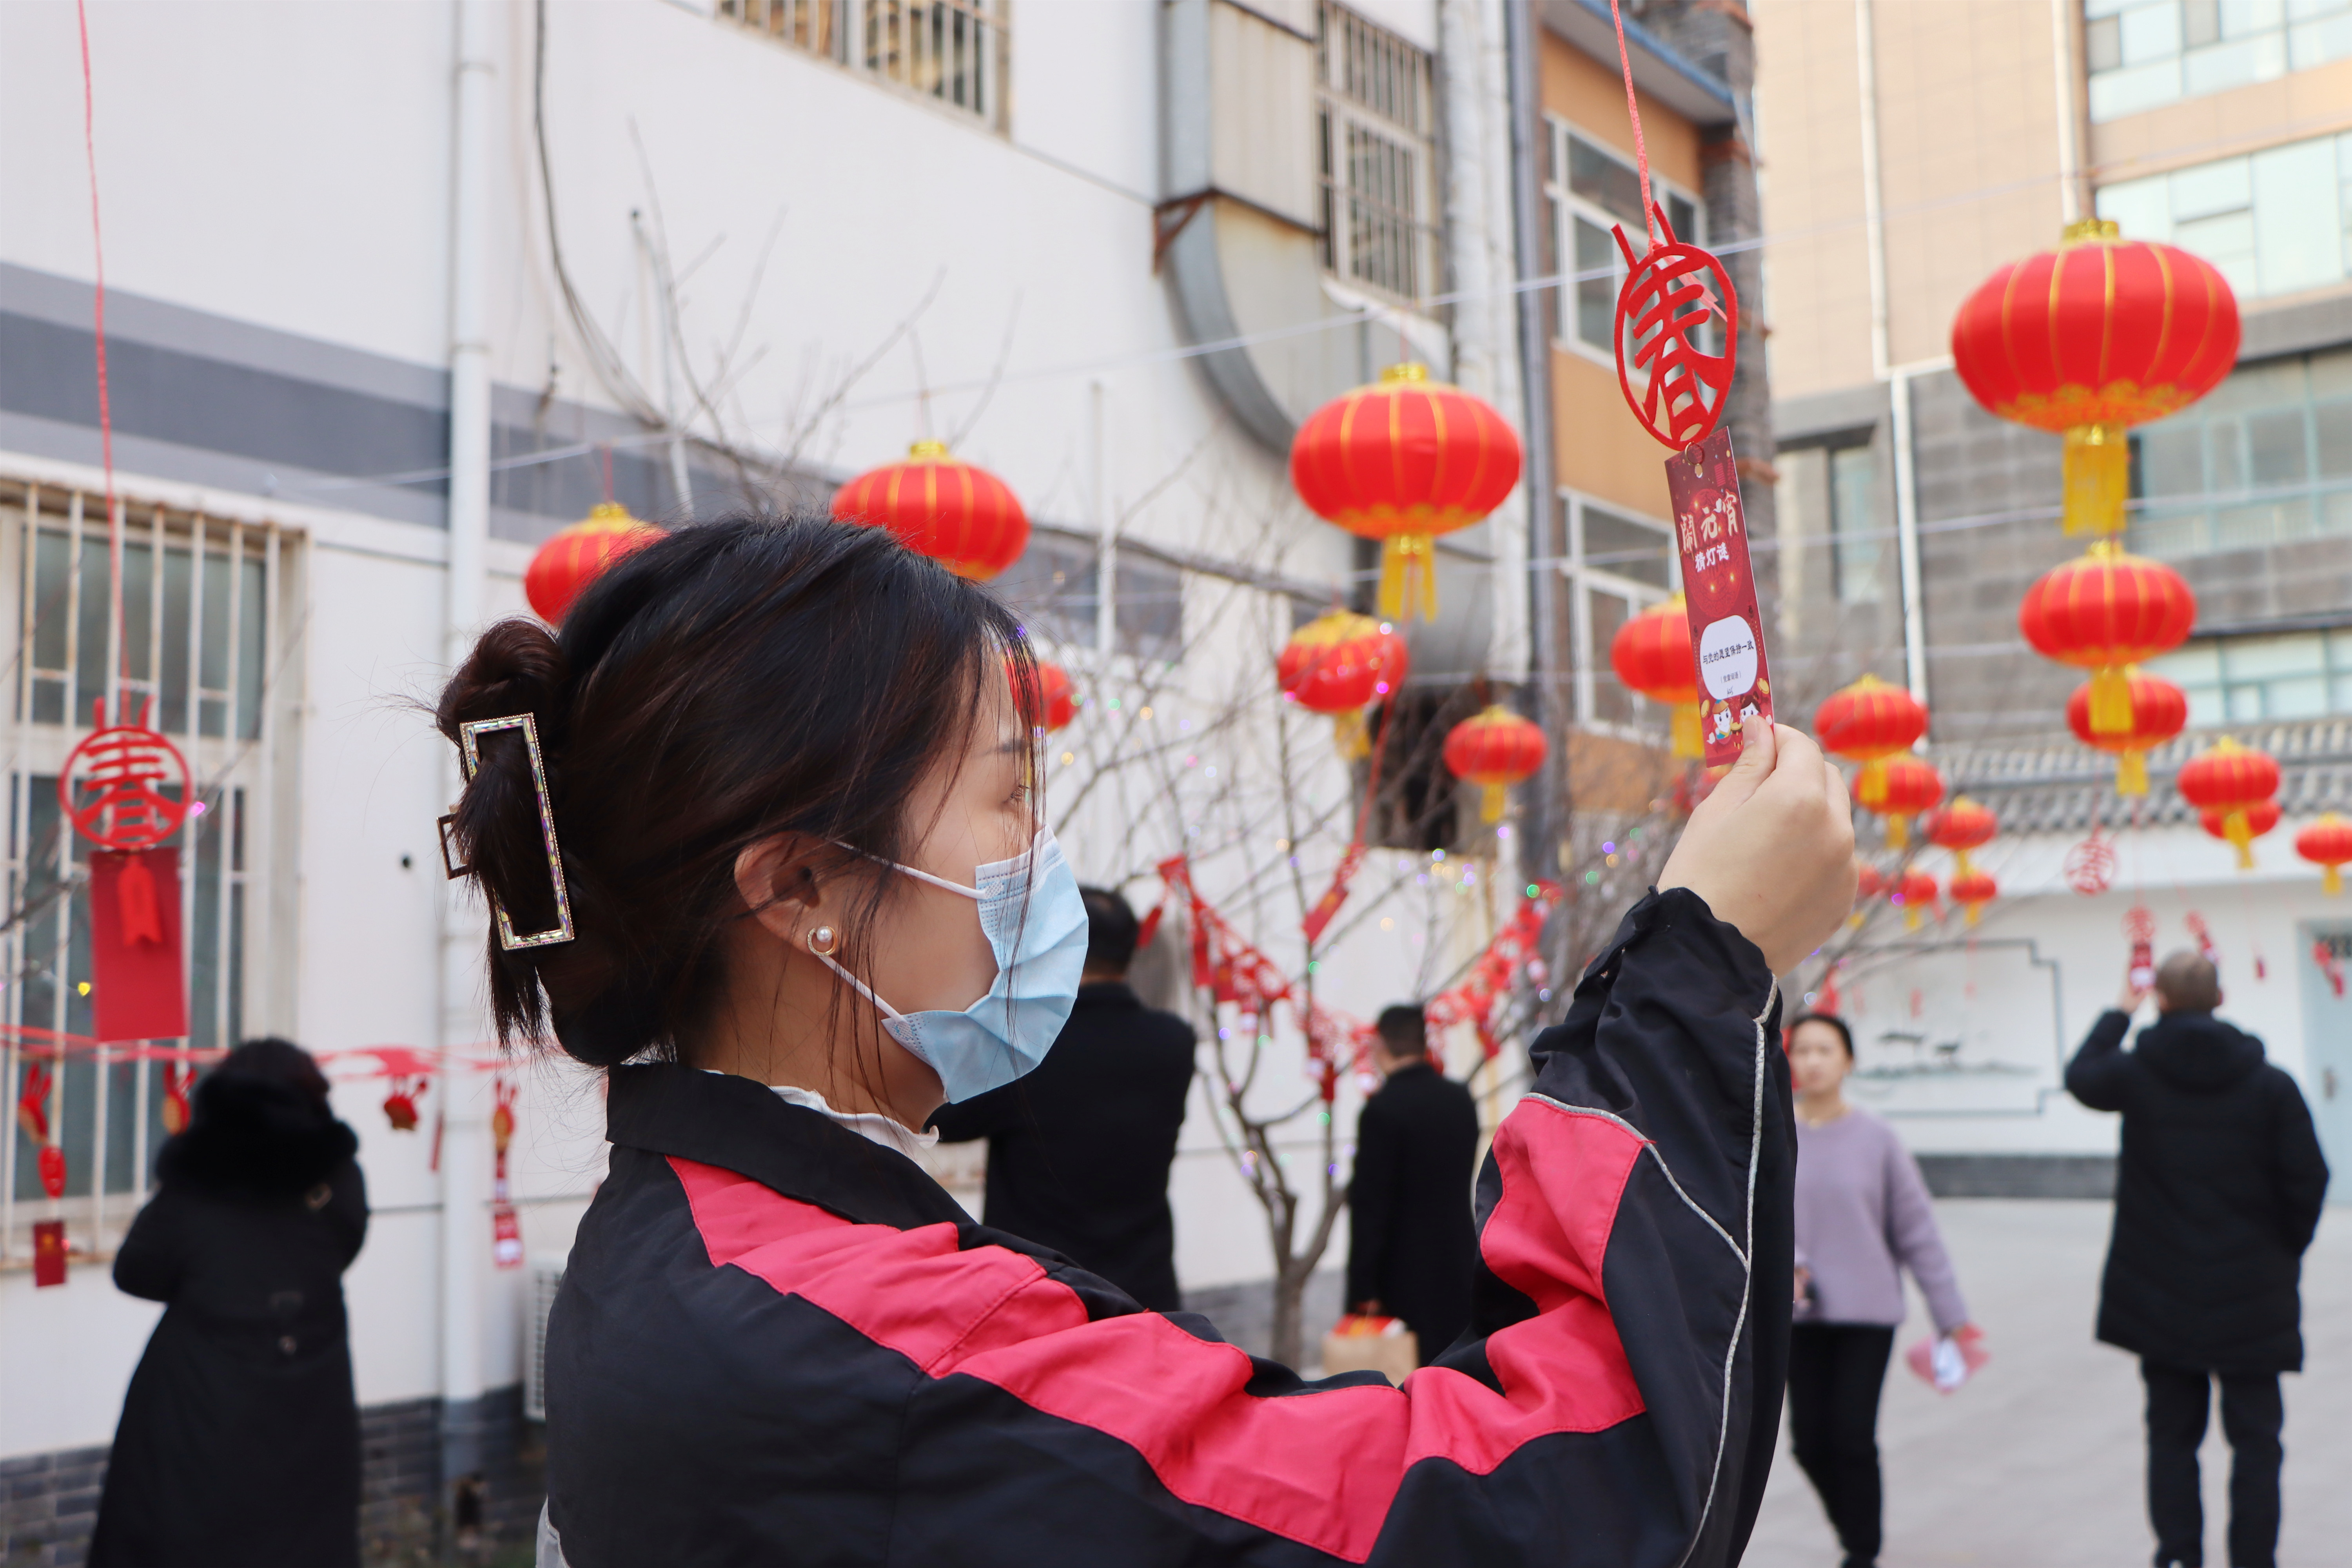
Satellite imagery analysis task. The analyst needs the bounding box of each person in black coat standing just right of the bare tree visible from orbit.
[1348,1006,1477,1361]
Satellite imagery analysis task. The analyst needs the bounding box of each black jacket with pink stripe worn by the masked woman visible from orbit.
[541,891,1792,1568]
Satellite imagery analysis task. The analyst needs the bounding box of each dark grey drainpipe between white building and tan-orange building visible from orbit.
[1503,0,1571,882]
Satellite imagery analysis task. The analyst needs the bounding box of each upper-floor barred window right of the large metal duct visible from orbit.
[1315,0,1437,301]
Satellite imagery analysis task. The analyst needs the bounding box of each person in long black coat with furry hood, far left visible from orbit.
[89,1039,367,1568]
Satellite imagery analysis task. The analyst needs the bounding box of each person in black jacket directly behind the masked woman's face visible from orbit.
[931,889,1192,1312]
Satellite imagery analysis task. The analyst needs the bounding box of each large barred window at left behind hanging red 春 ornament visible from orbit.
[0,479,287,1262]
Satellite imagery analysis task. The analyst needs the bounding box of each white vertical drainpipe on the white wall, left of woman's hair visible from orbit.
[435,0,494,1504]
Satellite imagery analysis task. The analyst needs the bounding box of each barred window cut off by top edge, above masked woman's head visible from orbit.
[717,0,1011,129]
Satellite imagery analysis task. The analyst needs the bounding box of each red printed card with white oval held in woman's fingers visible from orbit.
[1665,430,1771,769]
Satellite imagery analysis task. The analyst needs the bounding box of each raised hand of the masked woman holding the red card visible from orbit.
[1658,719,1856,976]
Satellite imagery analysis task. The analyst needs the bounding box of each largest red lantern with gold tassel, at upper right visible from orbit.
[1952,219,2239,534]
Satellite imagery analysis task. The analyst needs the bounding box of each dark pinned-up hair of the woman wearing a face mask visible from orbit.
[435,515,1035,1067]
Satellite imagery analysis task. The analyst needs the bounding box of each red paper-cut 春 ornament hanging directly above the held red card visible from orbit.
[1616,205,1740,451]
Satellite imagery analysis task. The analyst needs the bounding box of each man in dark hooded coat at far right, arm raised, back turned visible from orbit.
[2065,952,2328,1568]
